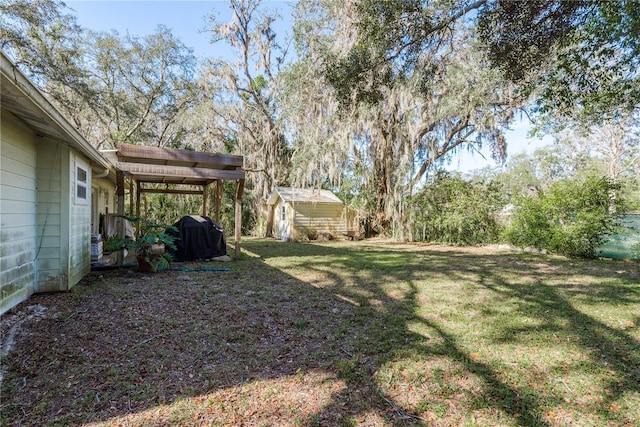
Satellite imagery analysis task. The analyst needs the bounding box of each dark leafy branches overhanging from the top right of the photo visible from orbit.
[327,0,640,121]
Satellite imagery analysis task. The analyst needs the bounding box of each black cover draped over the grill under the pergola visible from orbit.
[167,215,227,262]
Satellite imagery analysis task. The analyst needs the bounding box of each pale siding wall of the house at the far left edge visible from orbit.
[0,114,37,313]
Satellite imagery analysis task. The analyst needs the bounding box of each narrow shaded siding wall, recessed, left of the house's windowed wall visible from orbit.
[37,140,70,292]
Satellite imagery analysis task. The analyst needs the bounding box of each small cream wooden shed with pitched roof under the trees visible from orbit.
[267,187,353,241]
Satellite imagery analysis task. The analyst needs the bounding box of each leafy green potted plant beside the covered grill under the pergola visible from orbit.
[107,215,178,273]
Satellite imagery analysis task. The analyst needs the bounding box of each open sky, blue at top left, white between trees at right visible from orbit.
[65,0,551,172]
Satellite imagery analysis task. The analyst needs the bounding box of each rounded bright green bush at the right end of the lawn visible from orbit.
[505,176,621,258]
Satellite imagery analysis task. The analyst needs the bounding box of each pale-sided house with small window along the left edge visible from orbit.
[0,53,116,314]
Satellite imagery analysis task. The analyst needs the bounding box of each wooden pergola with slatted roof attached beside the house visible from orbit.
[110,144,245,259]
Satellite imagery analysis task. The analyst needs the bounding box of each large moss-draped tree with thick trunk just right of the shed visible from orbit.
[296,1,521,239]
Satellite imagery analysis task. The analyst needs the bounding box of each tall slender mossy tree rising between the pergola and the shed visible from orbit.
[206,0,291,211]
